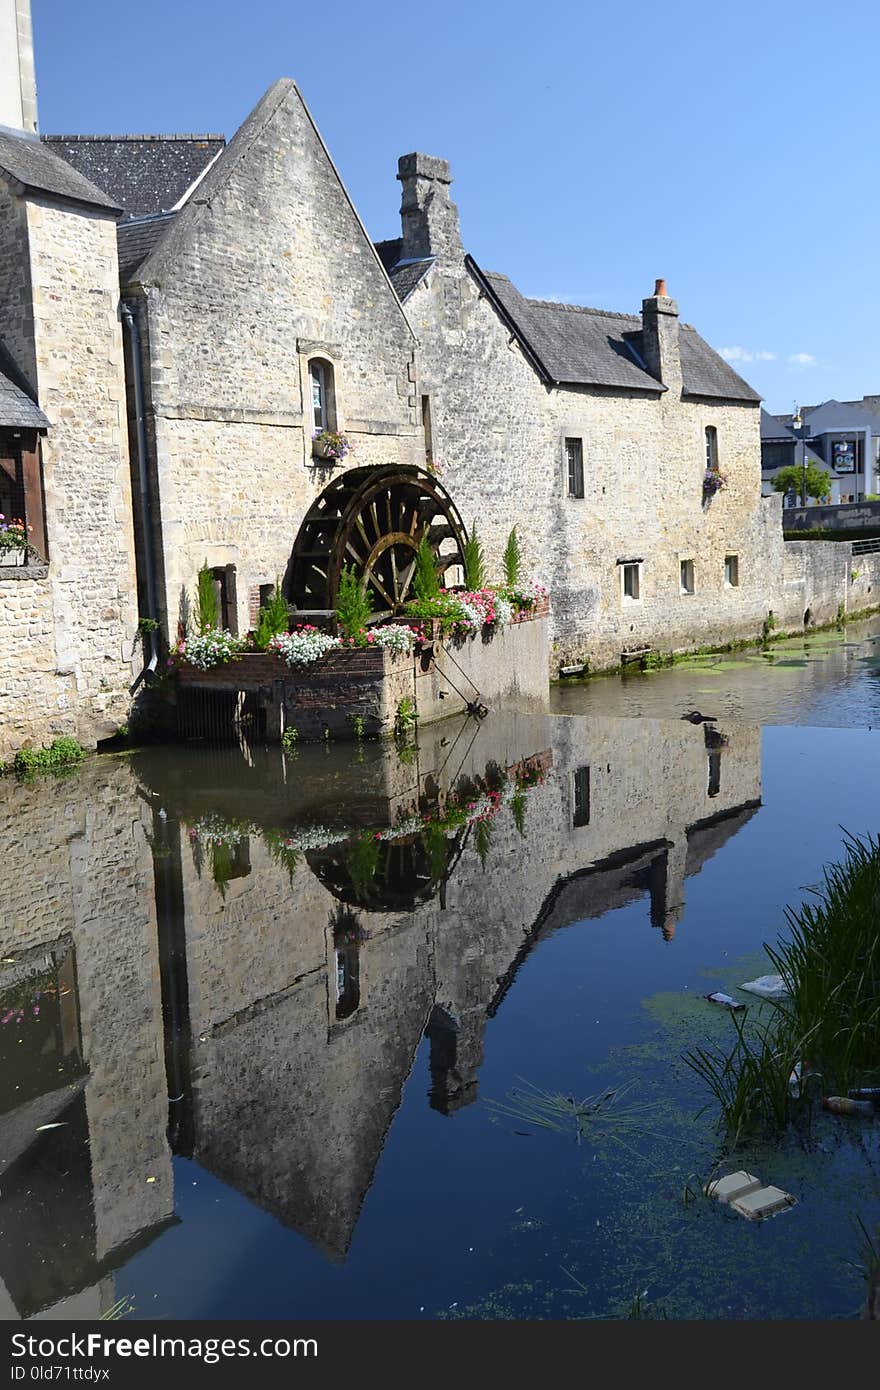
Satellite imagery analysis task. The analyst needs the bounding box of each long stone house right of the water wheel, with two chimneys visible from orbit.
[380,154,783,674]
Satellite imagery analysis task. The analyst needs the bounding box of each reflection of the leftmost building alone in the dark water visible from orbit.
[0,762,174,1318]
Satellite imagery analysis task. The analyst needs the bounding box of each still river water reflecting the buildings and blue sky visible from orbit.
[0,624,880,1319]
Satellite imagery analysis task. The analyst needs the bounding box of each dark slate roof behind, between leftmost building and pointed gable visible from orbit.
[40,135,227,217]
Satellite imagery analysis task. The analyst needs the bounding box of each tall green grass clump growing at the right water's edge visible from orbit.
[684,835,880,1144]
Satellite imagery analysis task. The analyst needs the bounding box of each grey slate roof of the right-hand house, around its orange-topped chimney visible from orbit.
[478,257,760,403]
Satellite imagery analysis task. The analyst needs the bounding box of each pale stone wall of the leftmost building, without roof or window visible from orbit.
[0,190,138,758]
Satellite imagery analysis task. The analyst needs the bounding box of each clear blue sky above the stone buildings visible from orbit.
[32,0,880,411]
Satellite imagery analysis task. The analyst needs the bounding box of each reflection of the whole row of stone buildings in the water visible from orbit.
[0,714,760,1318]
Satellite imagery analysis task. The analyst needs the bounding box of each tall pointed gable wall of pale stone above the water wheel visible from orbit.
[131,82,424,637]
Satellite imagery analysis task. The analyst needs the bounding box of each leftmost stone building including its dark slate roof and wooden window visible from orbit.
[0,112,138,760]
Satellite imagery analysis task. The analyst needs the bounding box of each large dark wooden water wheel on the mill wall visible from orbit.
[288,464,464,617]
